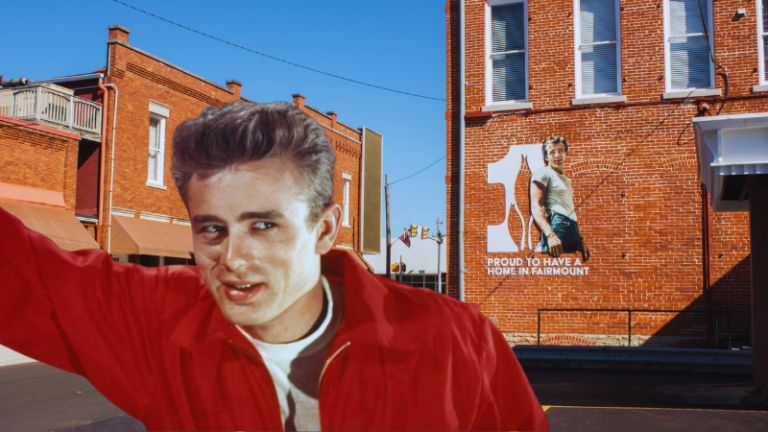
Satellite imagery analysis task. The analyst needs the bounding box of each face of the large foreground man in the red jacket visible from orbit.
[187,158,335,328]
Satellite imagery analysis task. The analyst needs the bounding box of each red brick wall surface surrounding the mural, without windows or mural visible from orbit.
[446,0,752,344]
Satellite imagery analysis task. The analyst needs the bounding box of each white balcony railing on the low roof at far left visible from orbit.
[0,85,102,135]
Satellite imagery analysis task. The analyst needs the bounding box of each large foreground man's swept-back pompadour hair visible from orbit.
[171,101,336,222]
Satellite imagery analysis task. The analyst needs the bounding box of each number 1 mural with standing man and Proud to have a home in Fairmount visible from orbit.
[487,136,591,276]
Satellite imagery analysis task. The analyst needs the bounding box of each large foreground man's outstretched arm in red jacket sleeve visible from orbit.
[0,209,165,417]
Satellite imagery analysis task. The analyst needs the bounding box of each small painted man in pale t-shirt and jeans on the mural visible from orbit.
[530,136,590,261]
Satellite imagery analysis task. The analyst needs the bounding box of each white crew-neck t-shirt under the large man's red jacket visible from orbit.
[238,277,344,431]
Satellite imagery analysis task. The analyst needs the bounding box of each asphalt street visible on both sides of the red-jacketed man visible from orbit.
[0,363,768,432]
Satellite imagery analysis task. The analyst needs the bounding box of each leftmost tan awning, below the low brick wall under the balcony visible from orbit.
[0,202,99,251]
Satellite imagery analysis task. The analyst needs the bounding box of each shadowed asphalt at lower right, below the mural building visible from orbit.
[526,368,768,432]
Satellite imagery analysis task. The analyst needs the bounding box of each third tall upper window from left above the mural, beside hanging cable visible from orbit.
[664,0,715,92]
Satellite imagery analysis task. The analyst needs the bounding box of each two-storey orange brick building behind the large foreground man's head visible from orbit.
[0,26,381,266]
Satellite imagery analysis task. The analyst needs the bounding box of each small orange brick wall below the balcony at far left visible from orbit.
[0,119,79,212]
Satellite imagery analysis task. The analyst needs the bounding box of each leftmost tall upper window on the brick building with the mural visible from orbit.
[485,0,528,105]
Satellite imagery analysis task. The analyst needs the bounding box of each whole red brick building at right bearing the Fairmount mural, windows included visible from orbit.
[446,0,768,347]
